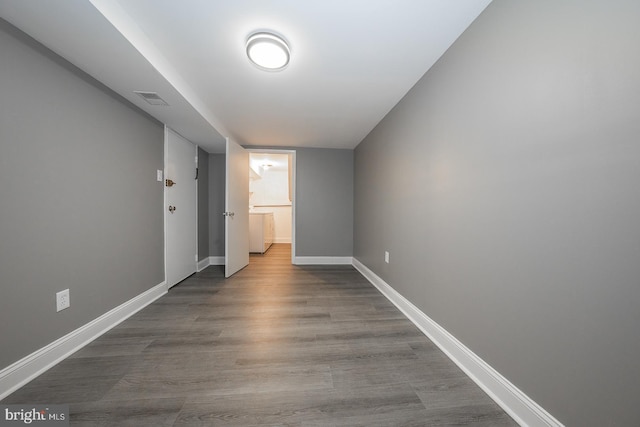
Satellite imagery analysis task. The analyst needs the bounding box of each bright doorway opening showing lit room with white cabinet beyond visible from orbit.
[248,149,295,263]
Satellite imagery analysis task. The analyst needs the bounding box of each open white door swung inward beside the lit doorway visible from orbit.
[224,138,249,277]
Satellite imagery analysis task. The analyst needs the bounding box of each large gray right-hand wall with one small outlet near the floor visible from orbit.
[355,0,640,426]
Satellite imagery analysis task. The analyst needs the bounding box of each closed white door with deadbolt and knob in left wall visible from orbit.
[164,127,198,287]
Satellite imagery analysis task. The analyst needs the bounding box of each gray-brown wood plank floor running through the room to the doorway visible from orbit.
[2,244,517,427]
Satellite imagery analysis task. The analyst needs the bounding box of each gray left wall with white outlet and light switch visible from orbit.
[0,20,164,369]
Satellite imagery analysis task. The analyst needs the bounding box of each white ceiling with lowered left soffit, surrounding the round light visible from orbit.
[0,0,491,152]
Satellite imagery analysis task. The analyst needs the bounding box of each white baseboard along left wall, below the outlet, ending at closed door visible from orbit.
[0,282,167,400]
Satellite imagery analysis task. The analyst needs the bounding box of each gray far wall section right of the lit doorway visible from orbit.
[295,148,353,256]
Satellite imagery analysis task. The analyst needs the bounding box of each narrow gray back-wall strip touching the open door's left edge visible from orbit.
[209,153,226,256]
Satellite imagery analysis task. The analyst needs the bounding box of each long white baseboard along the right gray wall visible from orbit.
[353,258,562,427]
